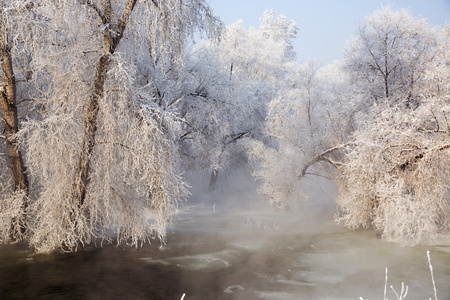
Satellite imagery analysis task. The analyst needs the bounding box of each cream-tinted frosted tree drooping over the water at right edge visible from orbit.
[336,97,450,242]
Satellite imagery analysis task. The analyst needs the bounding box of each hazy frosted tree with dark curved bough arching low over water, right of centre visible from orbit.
[246,61,353,208]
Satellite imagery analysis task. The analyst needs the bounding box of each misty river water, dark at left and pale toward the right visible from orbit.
[0,173,450,300]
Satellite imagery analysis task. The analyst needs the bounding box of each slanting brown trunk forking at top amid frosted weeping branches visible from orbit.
[73,0,137,206]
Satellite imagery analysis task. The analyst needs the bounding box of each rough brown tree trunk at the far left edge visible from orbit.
[0,12,28,236]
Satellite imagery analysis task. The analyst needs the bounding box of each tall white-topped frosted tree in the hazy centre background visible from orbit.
[182,12,296,187]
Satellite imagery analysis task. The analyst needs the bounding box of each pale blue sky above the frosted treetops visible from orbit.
[209,0,450,64]
